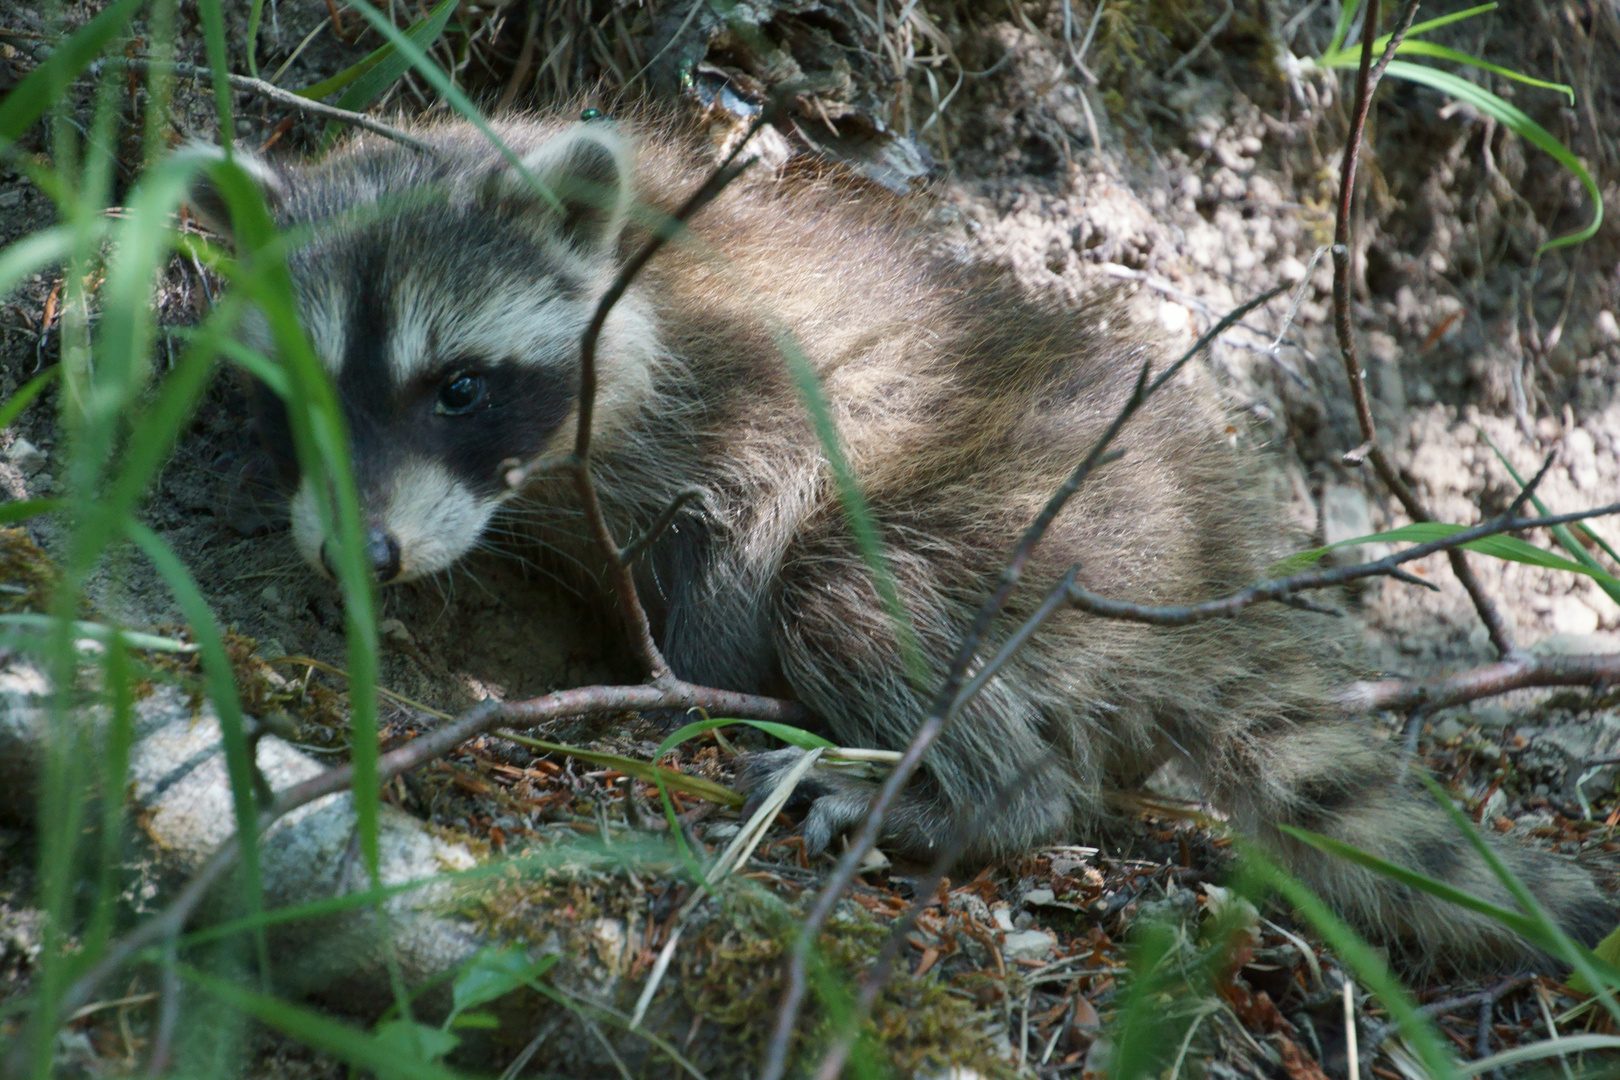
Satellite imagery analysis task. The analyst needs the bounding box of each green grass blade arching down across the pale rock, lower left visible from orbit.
[125,518,271,984]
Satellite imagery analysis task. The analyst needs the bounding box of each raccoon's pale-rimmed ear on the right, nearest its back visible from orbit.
[502,121,635,254]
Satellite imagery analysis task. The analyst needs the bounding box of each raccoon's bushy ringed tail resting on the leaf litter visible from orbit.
[1217,719,1617,968]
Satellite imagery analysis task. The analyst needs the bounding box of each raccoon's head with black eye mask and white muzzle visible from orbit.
[193,123,658,583]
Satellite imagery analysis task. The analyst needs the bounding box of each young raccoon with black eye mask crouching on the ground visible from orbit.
[208,117,1612,965]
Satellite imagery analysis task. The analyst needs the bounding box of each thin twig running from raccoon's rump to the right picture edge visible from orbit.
[1069,502,1620,627]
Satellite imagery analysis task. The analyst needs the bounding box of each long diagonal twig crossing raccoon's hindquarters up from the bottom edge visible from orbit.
[760,285,1288,1080]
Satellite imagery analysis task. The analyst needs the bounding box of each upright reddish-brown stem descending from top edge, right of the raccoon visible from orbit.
[1333,0,1518,656]
